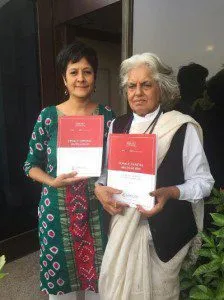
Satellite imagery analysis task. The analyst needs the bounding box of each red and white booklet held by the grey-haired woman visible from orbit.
[107,134,157,209]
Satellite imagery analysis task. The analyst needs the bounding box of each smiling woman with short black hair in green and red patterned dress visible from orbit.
[24,41,114,300]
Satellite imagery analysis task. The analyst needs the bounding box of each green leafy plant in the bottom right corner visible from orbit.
[180,189,224,300]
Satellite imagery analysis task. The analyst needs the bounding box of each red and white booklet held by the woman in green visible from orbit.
[57,115,104,177]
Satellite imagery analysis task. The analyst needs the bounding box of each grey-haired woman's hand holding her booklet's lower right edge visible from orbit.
[137,186,180,218]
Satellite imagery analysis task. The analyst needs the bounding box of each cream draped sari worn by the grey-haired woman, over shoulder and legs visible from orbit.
[99,111,212,300]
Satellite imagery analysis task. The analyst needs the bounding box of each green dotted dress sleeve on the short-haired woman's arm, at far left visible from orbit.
[23,109,49,176]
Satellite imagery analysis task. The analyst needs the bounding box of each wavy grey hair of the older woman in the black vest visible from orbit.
[120,53,180,110]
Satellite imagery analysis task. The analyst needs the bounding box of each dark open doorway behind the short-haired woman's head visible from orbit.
[56,2,122,113]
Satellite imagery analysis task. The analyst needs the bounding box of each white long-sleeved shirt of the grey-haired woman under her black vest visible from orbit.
[97,108,214,203]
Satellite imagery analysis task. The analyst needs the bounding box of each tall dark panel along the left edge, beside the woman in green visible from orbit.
[0,0,40,260]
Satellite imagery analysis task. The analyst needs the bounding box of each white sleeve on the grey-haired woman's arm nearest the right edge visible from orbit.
[177,123,214,203]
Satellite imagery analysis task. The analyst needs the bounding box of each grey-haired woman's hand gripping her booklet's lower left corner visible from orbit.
[95,184,129,215]
